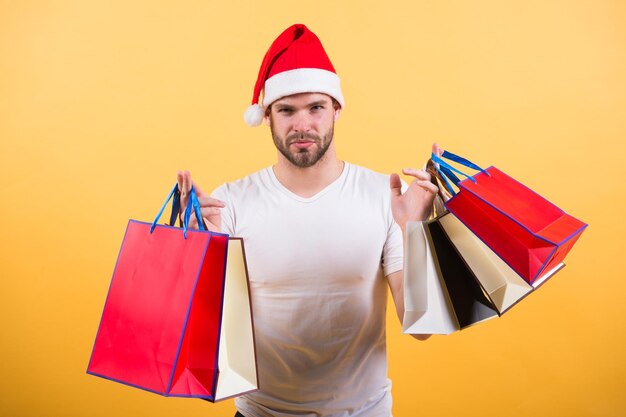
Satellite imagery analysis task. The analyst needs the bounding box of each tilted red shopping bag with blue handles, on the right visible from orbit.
[432,151,587,284]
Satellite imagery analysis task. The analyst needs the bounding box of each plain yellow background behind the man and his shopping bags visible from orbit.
[0,0,626,417]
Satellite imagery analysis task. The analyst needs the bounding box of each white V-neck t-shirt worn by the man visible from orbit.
[213,163,403,417]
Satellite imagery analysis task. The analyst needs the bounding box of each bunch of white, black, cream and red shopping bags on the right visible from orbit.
[402,151,587,334]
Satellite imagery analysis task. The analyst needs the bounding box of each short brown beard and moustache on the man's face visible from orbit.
[270,125,335,168]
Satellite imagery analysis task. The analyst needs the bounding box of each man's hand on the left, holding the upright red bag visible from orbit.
[176,171,226,232]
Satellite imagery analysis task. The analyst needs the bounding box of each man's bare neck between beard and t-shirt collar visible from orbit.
[272,143,344,198]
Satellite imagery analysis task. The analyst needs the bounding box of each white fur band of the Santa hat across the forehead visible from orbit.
[263,68,344,108]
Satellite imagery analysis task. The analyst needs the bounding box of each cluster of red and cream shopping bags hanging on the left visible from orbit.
[87,186,258,401]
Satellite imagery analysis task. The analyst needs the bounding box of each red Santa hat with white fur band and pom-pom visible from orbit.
[243,24,344,126]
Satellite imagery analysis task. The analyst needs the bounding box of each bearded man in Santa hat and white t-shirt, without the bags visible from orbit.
[178,25,438,417]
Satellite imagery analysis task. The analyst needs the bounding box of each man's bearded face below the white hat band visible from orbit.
[266,93,339,168]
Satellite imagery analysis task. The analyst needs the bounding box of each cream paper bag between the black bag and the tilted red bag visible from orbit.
[436,213,565,315]
